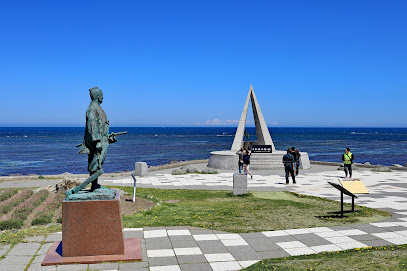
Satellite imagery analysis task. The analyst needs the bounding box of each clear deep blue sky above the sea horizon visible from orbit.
[0,0,407,127]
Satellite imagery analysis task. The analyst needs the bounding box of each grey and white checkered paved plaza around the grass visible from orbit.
[0,169,407,271]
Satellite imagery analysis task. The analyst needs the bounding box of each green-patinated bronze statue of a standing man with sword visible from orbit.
[66,87,127,200]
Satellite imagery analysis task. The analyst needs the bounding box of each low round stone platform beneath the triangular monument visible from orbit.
[208,151,311,171]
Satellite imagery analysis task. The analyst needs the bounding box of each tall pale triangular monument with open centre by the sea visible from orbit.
[231,85,276,152]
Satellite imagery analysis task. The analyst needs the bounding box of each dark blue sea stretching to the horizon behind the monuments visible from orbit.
[0,127,407,176]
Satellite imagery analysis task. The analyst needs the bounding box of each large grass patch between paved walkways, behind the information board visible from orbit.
[110,187,391,232]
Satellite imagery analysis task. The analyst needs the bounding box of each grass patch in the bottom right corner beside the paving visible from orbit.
[243,245,407,271]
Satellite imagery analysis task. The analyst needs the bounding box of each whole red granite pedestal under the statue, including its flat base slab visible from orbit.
[41,194,142,266]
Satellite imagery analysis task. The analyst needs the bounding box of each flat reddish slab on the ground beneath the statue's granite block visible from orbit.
[41,238,142,266]
